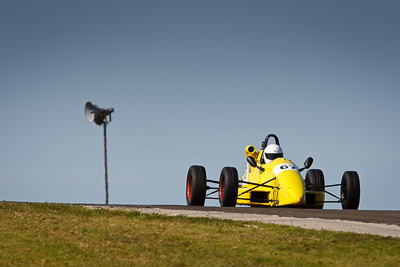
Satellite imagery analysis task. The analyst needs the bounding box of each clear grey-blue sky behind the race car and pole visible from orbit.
[0,0,400,210]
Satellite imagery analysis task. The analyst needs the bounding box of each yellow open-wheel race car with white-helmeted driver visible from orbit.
[186,134,360,209]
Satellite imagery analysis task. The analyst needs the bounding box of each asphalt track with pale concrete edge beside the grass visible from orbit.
[83,204,400,238]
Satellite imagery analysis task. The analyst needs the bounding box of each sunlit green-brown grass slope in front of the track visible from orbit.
[0,202,400,266]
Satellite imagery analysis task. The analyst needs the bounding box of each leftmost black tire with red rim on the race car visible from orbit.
[186,165,207,206]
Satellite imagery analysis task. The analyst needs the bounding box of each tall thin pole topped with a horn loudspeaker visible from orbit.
[85,101,114,205]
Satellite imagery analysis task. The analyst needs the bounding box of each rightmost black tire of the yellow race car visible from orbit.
[340,171,360,210]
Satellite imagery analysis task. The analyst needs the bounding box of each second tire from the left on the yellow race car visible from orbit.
[218,167,239,207]
